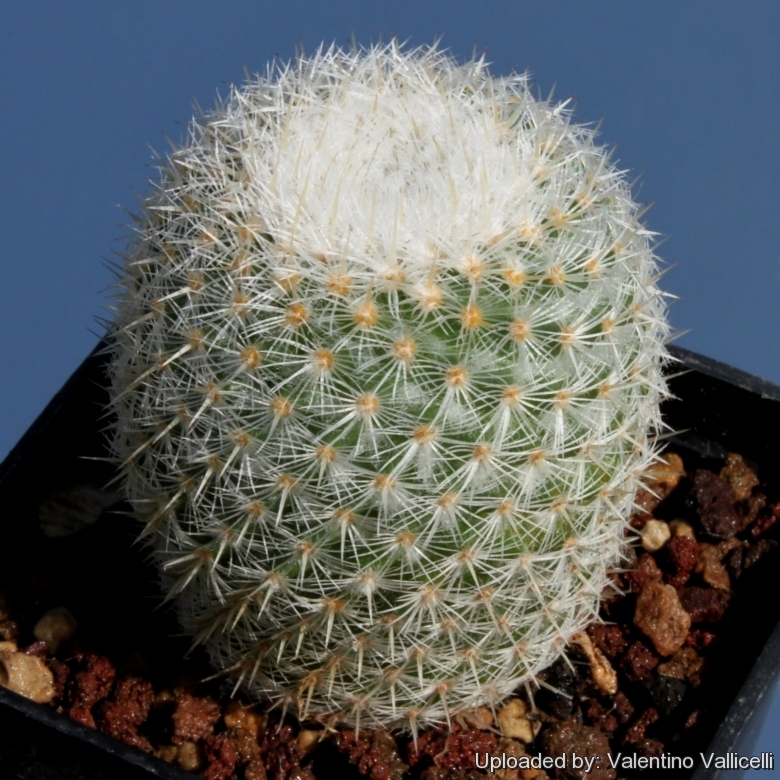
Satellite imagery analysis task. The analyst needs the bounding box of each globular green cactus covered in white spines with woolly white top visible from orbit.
[112,44,668,730]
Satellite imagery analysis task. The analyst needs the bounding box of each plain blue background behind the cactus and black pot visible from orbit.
[0,0,780,777]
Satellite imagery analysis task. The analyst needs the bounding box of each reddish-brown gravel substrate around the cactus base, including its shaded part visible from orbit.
[0,453,780,780]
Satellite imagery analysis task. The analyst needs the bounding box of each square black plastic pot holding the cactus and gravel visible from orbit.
[0,345,780,780]
